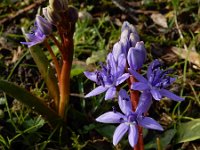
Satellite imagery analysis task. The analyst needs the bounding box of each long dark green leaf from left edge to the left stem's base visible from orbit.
[0,80,61,125]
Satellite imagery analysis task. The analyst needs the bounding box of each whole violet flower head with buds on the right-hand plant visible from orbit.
[84,21,184,147]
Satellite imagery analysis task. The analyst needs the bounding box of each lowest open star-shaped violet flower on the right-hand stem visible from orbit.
[96,89,163,147]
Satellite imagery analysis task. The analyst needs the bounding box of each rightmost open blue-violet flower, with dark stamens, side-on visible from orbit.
[129,60,184,101]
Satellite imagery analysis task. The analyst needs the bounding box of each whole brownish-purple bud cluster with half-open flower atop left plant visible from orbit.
[21,0,78,47]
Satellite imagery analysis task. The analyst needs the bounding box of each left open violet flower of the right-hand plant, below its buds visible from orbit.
[84,53,129,100]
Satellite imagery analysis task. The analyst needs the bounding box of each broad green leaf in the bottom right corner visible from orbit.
[175,119,200,143]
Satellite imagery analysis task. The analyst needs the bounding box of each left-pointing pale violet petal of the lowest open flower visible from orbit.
[96,111,124,123]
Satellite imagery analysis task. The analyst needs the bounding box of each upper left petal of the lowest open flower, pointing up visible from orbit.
[118,89,132,114]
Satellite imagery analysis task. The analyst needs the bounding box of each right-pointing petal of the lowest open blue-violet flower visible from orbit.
[138,117,163,131]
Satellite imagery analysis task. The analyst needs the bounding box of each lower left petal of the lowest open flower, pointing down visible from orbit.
[113,123,129,145]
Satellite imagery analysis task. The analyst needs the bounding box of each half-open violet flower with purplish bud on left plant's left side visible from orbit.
[21,15,52,47]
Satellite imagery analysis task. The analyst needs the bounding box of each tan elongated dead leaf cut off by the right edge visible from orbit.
[171,47,200,68]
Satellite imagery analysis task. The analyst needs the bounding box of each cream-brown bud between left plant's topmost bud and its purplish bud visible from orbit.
[43,7,61,25]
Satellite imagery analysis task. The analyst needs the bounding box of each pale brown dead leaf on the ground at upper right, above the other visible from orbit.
[151,13,168,28]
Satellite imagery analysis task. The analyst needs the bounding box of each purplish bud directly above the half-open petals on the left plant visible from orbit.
[36,15,52,35]
